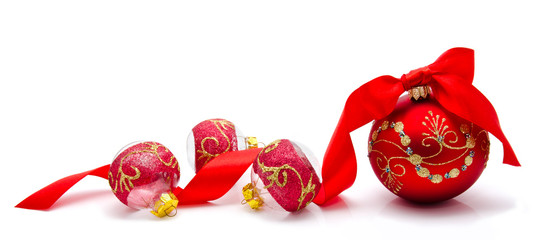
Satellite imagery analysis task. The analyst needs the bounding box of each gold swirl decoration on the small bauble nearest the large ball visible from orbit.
[257,140,316,210]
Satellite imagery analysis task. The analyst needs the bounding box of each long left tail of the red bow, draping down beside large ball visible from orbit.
[313,76,404,205]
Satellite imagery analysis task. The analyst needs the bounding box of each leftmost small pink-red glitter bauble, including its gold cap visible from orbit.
[108,142,180,217]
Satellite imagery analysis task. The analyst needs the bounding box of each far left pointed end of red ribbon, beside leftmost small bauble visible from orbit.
[15,164,109,210]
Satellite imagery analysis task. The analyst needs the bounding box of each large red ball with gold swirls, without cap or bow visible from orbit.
[368,94,490,203]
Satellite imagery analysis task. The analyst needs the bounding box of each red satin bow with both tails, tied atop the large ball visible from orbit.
[314,48,520,205]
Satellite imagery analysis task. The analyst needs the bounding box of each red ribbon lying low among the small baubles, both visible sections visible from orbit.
[15,148,261,210]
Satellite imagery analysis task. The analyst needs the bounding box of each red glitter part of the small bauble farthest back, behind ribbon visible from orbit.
[193,119,238,172]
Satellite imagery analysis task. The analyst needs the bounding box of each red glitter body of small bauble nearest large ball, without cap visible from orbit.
[253,139,321,212]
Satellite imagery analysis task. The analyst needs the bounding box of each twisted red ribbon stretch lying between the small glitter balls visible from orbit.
[174,148,261,205]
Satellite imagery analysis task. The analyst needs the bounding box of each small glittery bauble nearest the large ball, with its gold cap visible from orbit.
[243,139,321,212]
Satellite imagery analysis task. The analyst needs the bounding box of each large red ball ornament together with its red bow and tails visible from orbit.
[315,48,520,204]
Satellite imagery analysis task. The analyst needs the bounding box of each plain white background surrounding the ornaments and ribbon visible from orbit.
[0,0,543,239]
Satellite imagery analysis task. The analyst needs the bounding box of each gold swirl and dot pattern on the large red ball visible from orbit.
[368,111,489,193]
